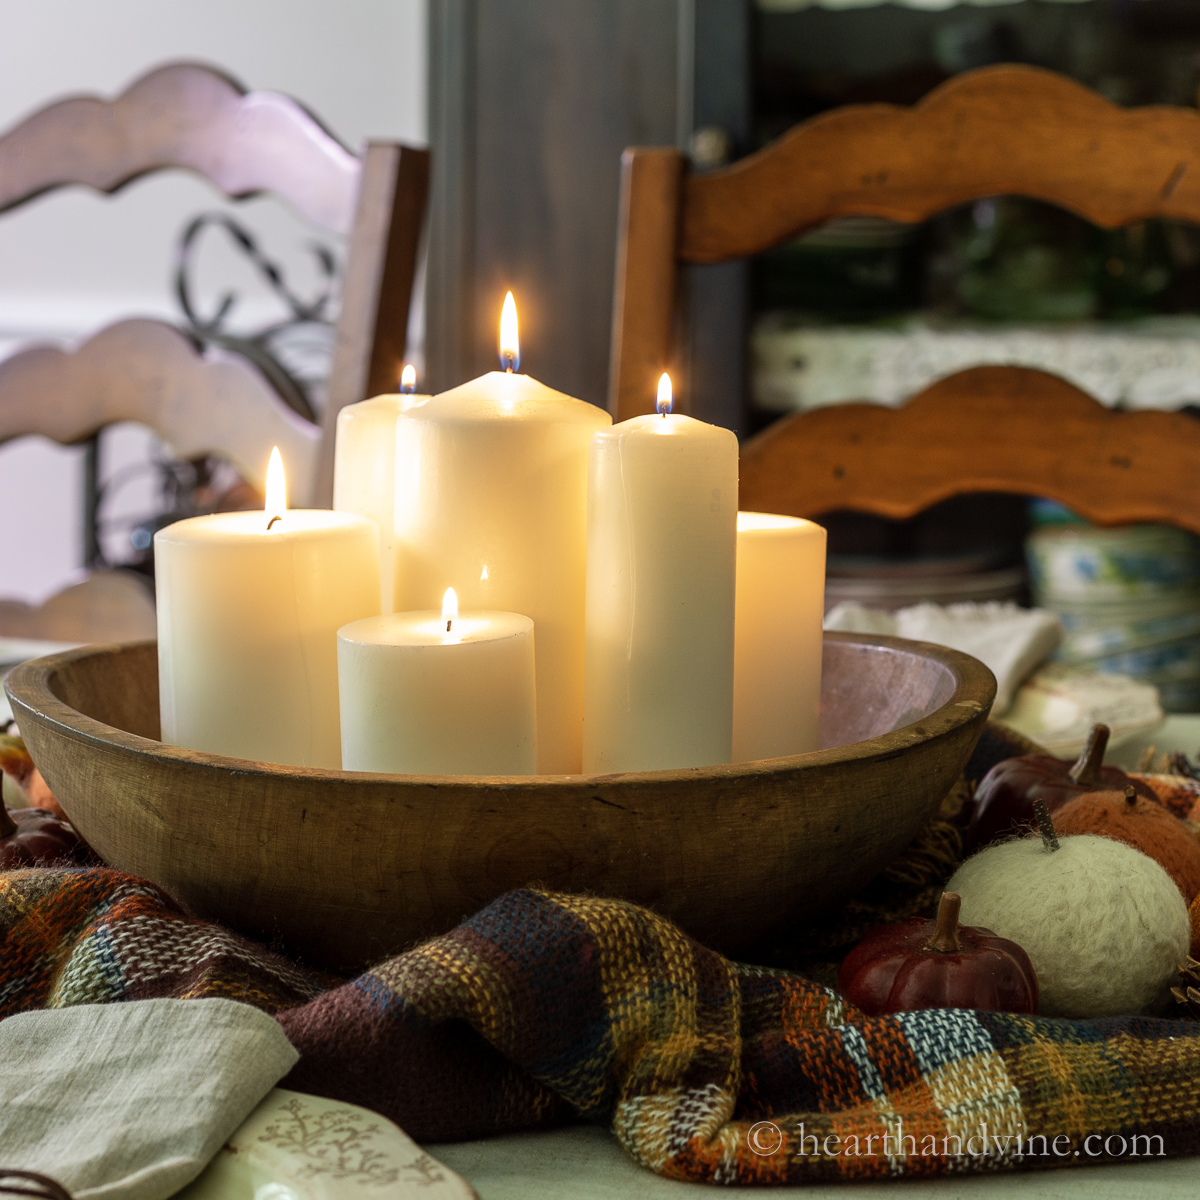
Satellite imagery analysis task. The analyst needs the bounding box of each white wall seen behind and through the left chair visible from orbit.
[0,0,427,602]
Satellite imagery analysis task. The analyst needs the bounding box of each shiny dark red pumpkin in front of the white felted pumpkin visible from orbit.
[838,892,1038,1016]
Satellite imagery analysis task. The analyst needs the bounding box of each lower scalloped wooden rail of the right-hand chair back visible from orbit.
[738,366,1200,534]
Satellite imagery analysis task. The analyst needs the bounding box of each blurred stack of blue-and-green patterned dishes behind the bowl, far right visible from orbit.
[1026,524,1200,713]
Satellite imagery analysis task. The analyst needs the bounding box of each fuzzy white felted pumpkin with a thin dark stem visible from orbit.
[946,815,1192,1018]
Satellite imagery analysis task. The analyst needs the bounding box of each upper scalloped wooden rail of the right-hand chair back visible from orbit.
[681,65,1200,263]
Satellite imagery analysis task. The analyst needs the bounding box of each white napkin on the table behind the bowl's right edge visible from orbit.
[824,600,1062,716]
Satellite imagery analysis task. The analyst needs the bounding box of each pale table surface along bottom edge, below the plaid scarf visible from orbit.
[436,1126,1200,1200]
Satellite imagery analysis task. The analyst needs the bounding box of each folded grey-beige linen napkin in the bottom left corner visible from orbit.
[0,1000,299,1200]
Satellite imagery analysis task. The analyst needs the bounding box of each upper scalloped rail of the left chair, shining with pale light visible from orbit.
[0,62,362,234]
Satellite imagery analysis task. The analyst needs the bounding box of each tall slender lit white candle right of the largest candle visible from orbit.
[583,376,738,773]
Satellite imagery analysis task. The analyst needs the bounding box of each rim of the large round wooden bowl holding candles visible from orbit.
[4,630,996,791]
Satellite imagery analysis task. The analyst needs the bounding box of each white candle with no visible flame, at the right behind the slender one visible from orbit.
[733,512,826,762]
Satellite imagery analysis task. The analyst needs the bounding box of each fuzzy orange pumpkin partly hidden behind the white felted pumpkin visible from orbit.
[1054,787,1200,904]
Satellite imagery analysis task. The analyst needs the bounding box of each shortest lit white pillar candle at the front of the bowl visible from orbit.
[337,589,538,775]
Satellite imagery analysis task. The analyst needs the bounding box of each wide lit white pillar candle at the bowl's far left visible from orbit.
[154,455,379,769]
